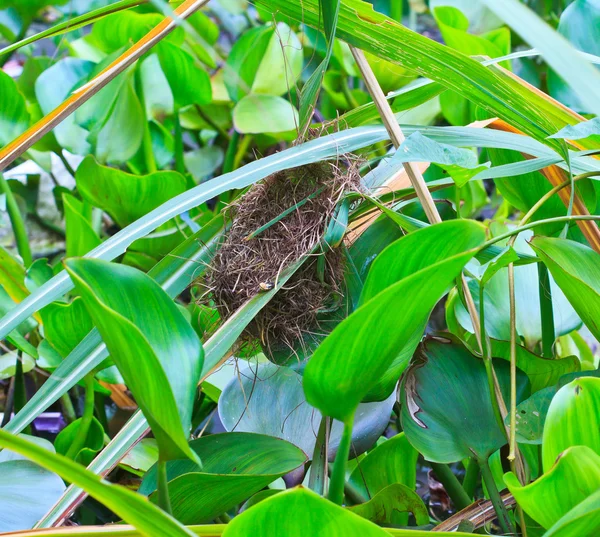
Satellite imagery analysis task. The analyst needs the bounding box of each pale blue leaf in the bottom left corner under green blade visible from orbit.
[0,458,65,533]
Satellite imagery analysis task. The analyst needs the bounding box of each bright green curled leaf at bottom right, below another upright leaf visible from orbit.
[504,446,600,529]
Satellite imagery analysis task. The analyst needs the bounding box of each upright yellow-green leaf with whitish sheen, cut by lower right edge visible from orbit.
[542,377,600,472]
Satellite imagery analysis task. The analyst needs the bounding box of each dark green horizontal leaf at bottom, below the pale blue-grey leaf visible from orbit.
[139,433,306,524]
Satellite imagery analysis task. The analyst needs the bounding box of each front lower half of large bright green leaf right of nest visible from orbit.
[303,243,475,422]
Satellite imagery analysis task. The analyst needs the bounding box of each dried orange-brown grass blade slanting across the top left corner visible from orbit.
[0,0,208,171]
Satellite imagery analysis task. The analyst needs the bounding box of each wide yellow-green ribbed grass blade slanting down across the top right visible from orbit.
[253,0,560,149]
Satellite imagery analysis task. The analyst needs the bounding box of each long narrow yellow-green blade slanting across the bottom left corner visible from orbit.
[0,429,194,537]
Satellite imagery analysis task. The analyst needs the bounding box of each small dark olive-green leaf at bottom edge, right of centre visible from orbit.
[347,484,429,526]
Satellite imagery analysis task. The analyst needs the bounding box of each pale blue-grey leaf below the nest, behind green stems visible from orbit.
[219,363,394,460]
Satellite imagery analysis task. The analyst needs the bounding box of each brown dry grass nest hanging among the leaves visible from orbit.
[206,157,360,351]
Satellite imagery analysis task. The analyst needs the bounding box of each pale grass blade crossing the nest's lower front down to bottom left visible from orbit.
[36,258,307,528]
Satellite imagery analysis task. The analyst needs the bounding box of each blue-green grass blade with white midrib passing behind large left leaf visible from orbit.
[5,215,224,434]
